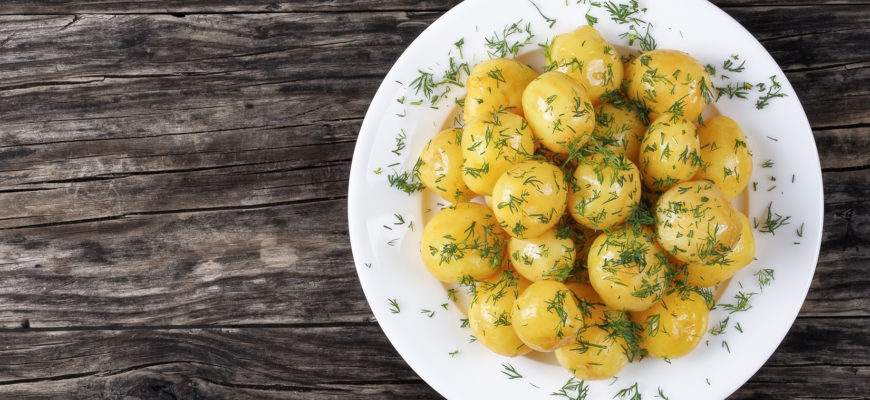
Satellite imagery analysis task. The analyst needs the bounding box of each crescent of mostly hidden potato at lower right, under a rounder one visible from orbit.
[686,211,755,287]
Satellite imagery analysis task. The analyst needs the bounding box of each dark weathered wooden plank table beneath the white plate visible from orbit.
[0,0,870,399]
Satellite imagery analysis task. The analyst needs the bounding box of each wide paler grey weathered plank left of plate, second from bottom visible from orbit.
[0,199,372,328]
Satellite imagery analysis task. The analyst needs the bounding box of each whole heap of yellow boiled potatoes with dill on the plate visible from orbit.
[408,21,755,379]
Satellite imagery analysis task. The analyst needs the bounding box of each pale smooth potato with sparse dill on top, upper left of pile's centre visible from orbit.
[523,71,595,154]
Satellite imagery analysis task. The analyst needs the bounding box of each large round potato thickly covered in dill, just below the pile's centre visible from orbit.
[588,226,669,311]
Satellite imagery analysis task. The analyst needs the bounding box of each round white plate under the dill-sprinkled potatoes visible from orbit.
[348,0,823,399]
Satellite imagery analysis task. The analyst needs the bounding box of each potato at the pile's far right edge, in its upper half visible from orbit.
[697,115,752,200]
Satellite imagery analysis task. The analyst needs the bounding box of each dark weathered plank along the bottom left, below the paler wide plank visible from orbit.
[0,324,419,397]
